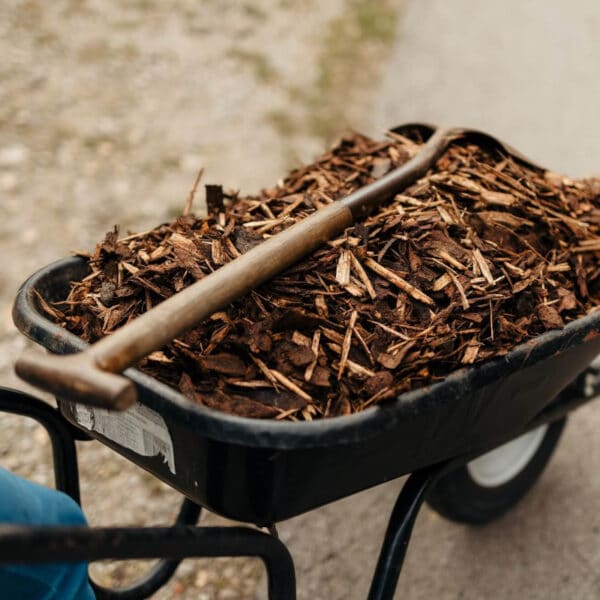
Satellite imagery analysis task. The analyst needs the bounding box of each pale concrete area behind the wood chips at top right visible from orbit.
[373,0,600,177]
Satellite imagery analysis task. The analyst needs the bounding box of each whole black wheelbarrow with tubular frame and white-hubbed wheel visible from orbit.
[0,125,600,600]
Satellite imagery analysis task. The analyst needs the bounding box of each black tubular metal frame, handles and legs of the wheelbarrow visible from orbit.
[0,378,600,600]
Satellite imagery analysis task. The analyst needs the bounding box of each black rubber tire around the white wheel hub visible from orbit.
[427,417,567,525]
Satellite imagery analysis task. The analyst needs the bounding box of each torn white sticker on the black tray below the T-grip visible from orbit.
[75,403,175,474]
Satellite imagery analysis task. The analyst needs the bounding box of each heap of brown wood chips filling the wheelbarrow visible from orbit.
[45,133,600,420]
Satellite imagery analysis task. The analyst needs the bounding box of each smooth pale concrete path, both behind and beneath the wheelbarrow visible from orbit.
[281,0,600,600]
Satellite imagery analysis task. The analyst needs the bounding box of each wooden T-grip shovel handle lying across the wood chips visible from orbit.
[15,129,462,409]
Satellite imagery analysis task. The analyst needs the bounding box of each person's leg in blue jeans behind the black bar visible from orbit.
[0,467,94,600]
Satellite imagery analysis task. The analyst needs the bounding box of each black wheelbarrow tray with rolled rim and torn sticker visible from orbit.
[14,253,600,525]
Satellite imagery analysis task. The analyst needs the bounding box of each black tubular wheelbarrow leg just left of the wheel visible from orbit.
[368,463,448,600]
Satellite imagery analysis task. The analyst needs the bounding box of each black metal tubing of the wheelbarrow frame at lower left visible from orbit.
[0,386,296,600]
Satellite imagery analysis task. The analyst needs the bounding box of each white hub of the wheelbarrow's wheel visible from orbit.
[467,425,548,487]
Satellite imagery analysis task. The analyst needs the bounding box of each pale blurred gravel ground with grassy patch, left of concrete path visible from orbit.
[0,0,398,600]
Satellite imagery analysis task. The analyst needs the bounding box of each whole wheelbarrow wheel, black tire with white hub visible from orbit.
[427,417,567,525]
